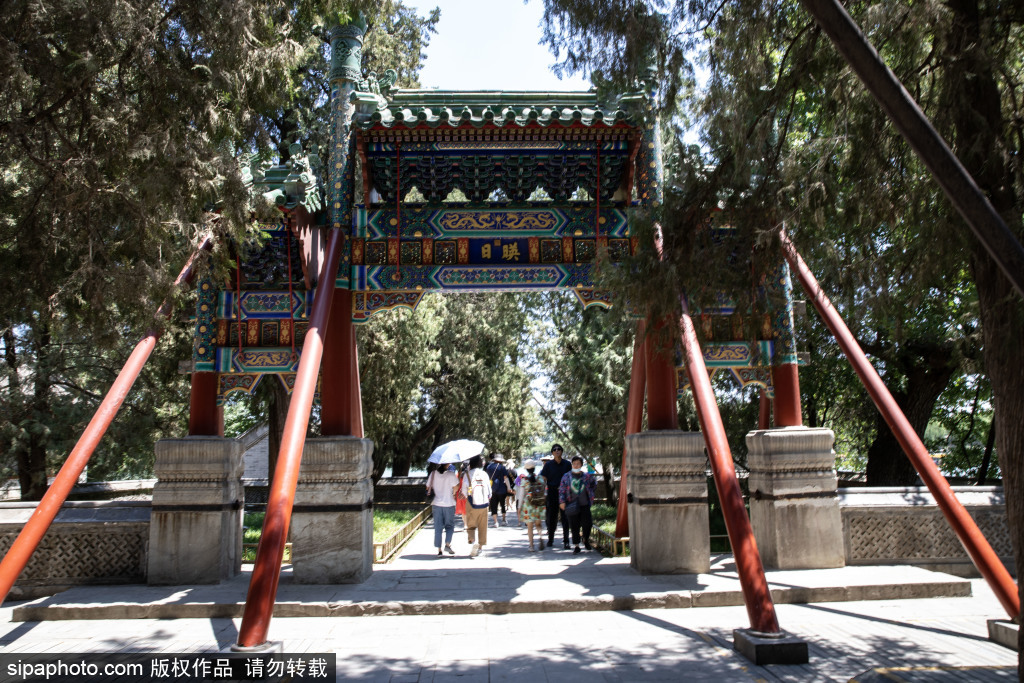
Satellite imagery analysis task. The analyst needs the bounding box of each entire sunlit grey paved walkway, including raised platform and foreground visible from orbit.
[0,511,1017,683]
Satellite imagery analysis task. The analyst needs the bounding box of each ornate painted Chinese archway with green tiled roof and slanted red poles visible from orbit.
[0,13,1019,661]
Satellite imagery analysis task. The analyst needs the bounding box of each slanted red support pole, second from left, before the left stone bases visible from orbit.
[238,229,345,647]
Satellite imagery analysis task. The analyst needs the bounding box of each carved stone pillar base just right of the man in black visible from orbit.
[626,430,711,573]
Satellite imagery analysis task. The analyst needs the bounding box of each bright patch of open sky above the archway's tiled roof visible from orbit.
[406,0,590,91]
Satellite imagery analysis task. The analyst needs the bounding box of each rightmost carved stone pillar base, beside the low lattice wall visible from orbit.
[746,427,846,569]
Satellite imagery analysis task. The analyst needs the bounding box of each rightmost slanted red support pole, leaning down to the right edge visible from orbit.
[779,230,1021,620]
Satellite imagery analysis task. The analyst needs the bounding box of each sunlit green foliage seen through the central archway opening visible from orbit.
[358,294,540,477]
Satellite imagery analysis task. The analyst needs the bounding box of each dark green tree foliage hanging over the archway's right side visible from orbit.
[545,0,1024,483]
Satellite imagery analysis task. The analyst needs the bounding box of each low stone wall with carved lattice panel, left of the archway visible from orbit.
[0,501,152,599]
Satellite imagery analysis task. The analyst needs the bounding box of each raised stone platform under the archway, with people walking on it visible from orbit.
[13,516,971,621]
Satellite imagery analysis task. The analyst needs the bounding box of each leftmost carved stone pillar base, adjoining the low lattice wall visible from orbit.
[146,436,245,586]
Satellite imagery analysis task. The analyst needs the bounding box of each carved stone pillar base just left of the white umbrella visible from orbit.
[291,436,374,584]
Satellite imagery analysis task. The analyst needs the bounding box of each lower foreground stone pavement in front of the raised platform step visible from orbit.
[0,580,1017,683]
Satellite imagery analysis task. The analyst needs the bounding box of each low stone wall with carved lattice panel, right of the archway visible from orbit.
[838,486,1013,577]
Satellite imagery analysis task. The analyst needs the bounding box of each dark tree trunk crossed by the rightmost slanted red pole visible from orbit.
[867,344,955,486]
